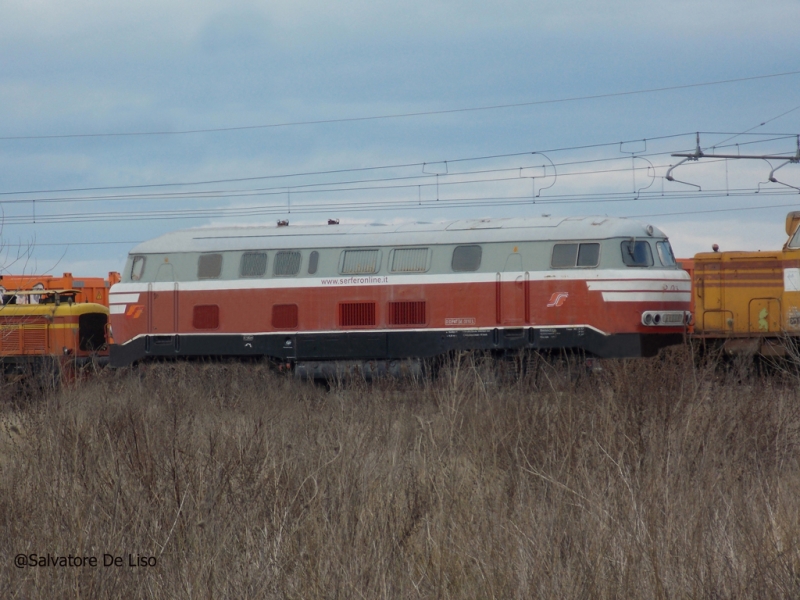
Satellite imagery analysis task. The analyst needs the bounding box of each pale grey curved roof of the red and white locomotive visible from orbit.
[131,217,665,254]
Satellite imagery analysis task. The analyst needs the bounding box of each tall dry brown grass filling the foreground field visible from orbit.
[0,352,800,599]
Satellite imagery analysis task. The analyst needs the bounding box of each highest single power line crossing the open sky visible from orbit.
[0,71,800,140]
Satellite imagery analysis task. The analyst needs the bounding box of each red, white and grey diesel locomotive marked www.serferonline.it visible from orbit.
[110,217,691,368]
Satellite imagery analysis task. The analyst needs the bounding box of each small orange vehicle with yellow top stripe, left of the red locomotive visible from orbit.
[0,290,108,375]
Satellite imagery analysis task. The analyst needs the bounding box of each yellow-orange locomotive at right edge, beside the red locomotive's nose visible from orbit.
[682,211,800,356]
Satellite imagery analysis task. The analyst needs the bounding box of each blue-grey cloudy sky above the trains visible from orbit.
[0,0,800,275]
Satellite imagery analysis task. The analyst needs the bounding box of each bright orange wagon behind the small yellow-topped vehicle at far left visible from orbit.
[0,271,120,306]
